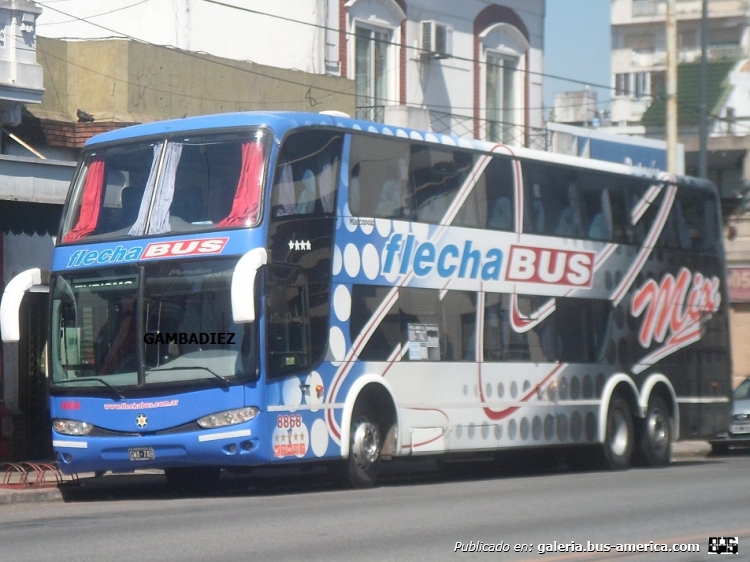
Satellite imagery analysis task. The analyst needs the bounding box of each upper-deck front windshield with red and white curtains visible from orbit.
[62,129,270,243]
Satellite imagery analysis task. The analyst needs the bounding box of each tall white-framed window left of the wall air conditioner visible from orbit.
[354,24,391,122]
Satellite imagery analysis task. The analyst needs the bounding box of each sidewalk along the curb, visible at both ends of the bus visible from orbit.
[0,441,711,508]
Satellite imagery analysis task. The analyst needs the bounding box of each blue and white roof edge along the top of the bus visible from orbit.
[84,111,716,190]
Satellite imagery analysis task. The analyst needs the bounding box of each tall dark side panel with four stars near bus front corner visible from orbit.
[266,130,343,384]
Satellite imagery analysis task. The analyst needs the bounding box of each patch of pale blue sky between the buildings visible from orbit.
[544,0,612,118]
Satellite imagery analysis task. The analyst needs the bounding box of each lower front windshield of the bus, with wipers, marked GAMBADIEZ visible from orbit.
[52,260,255,388]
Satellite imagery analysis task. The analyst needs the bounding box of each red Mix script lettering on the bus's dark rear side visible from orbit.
[630,267,721,350]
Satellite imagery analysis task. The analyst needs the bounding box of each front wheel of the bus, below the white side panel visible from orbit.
[341,400,383,488]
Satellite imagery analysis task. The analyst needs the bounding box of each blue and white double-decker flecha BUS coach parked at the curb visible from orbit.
[0,113,731,486]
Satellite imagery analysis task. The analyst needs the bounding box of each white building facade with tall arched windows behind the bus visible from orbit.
[38,0,544,145]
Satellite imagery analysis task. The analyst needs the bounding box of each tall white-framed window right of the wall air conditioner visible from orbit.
[485,52,519,143]
